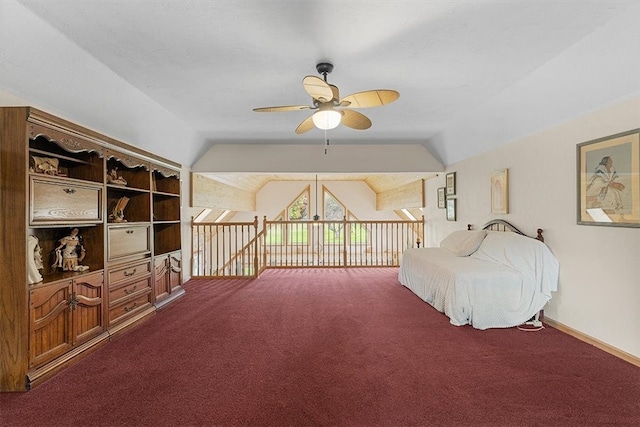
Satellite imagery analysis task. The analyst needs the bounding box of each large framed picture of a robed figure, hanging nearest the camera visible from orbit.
[577,129,640,227]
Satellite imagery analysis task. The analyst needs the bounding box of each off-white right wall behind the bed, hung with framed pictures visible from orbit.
[425,98,640,357]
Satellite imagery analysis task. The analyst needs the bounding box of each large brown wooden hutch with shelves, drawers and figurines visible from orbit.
[0,107,184,391]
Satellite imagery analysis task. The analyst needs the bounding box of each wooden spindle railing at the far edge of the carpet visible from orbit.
[191,217,424,277]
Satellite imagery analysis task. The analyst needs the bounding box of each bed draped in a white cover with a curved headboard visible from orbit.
[398,220,559,329]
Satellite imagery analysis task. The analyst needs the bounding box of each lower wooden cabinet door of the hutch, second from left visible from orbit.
[70,272,104,345]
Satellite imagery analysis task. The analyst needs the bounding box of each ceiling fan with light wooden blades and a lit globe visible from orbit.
[253,62,400,134]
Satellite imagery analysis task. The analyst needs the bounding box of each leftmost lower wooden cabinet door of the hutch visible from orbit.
[29,280,73,368]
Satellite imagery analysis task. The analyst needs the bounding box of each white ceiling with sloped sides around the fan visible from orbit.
[0,0,640,177]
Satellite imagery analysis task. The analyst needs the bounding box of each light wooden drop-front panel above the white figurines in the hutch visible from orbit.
[29,176,102,225]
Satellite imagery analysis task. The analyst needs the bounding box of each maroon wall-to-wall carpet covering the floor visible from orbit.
[0,268,640,426]
